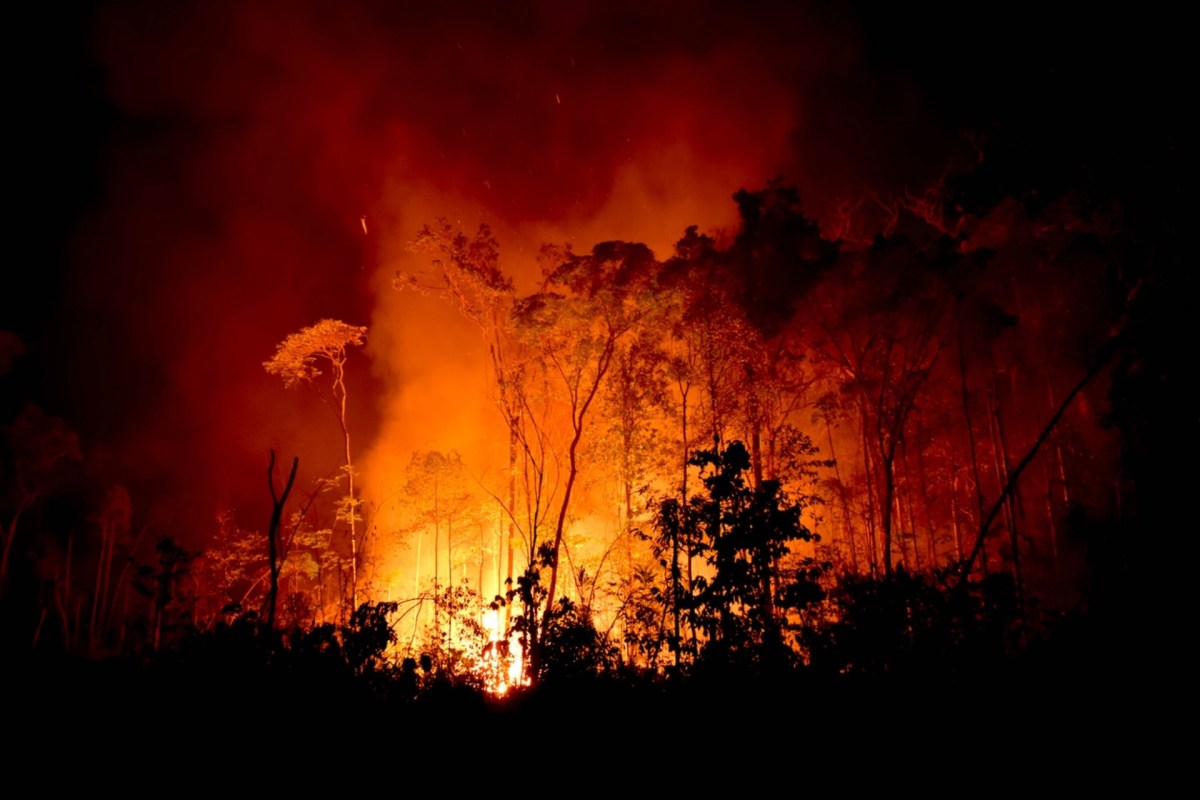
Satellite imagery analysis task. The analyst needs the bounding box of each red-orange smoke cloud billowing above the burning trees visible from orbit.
[56,1,969,542]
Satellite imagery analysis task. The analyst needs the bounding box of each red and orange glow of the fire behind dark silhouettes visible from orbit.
[35,2,1129,693]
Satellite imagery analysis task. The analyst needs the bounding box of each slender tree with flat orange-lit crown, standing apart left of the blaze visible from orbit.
[263,319,367,608]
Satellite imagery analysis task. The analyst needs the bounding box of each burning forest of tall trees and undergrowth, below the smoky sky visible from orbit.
[0,167,1176,697]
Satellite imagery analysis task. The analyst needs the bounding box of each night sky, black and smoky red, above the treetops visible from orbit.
[0,1,1183,541]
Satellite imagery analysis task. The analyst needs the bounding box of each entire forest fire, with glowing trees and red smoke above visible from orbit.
[0,2,1183,758]
